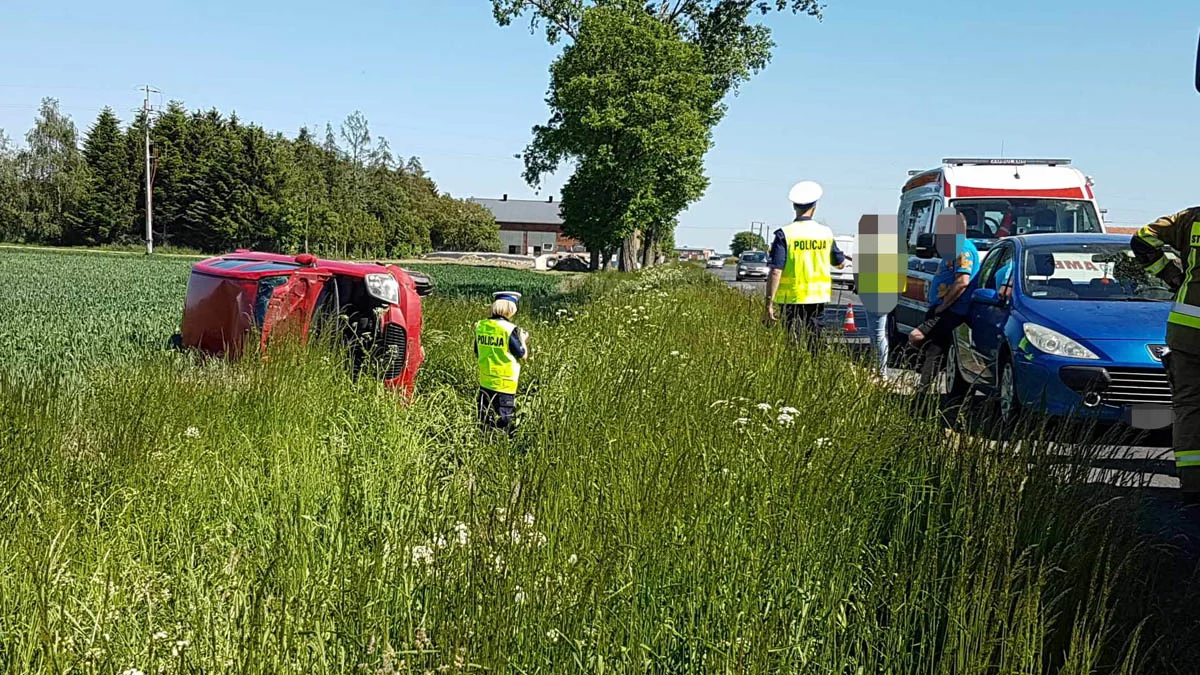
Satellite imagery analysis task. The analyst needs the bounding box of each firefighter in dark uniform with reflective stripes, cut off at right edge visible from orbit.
[1129,207,1200,502]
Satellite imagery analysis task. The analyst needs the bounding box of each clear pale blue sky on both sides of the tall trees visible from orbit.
[0,0,1200,249]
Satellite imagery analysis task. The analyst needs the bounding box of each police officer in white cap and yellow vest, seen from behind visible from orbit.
[767,180,846,336]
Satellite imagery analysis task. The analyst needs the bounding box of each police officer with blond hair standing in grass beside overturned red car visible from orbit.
[475,291,529,434]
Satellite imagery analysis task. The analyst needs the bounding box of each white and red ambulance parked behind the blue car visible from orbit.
[888,157,1104,336]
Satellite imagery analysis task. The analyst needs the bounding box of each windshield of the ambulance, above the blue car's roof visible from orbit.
[954,198,1103,239]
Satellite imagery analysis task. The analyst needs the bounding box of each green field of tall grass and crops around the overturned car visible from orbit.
[0,251,1196,675]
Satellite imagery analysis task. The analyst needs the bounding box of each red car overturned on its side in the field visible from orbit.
[173,249,432,393]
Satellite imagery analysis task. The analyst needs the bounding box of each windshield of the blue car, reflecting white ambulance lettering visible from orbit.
[1021,244,1177,301]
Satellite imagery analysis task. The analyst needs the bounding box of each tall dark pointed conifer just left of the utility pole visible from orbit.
[70,106,138,246]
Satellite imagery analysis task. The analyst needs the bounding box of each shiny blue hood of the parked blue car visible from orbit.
[1025,299,1171,342]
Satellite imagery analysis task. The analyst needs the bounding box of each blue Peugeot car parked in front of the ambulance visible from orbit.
[947,234,1174,429]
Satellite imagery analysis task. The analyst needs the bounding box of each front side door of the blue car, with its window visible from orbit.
[962,243,1016,383]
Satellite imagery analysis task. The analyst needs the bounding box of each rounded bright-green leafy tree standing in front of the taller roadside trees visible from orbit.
[513,7,718,269]
